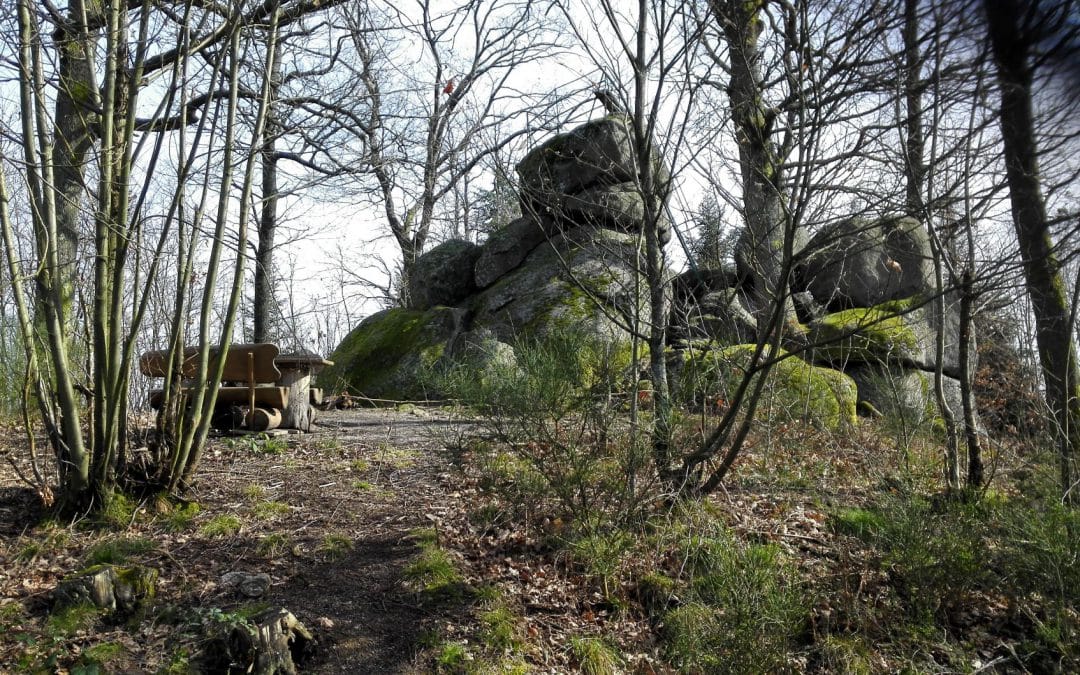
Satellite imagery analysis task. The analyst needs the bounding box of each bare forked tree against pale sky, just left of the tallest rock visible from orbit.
[336,0,559,300]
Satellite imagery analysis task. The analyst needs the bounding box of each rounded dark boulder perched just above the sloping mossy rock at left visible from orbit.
[408,239,481,310]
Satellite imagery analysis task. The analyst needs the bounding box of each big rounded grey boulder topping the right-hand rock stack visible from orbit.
[793,218,934,311]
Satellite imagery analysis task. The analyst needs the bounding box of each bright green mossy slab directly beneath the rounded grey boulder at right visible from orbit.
[811,298,920,363]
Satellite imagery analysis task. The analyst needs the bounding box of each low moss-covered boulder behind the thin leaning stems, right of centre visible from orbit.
[676,343,858,430]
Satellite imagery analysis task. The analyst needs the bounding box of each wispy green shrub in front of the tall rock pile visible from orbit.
[430,329,651,529]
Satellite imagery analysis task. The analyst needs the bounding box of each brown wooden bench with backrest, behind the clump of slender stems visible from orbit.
[139,343,289,431]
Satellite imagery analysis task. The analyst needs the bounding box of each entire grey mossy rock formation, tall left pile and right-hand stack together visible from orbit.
[320,114,974,428]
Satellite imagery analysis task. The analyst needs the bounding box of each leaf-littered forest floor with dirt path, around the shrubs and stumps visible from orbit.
[0,407,1076,673]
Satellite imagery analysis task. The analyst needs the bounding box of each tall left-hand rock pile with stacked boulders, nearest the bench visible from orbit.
[320,116,671,400]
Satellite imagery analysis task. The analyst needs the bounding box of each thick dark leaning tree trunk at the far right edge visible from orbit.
[983,0,1080,502]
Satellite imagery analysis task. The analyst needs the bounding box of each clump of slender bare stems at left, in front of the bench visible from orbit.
[0,0,343,509]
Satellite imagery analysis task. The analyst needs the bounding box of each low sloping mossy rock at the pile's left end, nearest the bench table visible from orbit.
[319,307,464,401]
